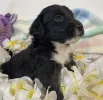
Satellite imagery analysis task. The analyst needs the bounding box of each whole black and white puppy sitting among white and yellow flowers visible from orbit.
[1,5,84,100]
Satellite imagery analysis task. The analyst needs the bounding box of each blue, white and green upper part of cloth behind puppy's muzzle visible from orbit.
[73,8,103,38]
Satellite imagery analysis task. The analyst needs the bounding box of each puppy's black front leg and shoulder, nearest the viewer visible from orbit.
[36,61,63,100]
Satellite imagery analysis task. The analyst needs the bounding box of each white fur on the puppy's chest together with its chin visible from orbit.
[52,37,80,67]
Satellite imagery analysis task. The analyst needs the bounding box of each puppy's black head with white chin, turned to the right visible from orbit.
[30,5,84,44]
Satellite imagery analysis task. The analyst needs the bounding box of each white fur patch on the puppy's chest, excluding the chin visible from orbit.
[52,42,71,66]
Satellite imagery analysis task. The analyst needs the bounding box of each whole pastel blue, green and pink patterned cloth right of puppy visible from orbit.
[73,8,103,54]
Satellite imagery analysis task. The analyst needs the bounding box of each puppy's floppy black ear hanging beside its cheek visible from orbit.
[30,15,45,38]
